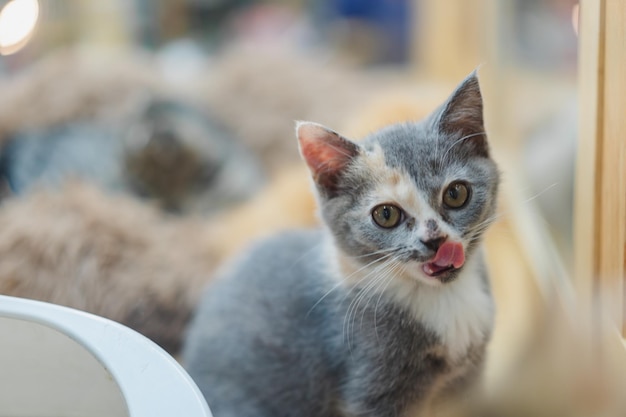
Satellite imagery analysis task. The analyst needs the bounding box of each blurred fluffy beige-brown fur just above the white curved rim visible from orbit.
[0,183,216,352]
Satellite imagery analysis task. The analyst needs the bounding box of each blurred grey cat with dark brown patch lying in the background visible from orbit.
[0,98,263,214]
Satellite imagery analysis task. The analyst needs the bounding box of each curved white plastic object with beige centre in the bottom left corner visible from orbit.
[0,295,211,417]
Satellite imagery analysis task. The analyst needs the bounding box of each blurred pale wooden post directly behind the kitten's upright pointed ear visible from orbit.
[412,0,508,143]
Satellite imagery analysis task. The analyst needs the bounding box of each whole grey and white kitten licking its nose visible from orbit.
[183,74,499,417]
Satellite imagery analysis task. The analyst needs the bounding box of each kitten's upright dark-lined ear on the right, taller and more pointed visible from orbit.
[439,71,489,157]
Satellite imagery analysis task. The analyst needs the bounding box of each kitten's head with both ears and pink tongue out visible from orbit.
[297,73,498,285]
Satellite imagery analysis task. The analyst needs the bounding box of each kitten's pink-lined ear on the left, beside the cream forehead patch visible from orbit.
[296,122,360,195]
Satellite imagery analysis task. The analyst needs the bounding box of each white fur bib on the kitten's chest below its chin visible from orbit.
[329,244,495,362]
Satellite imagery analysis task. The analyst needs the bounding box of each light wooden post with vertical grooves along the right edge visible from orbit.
[574,0,626,335]
